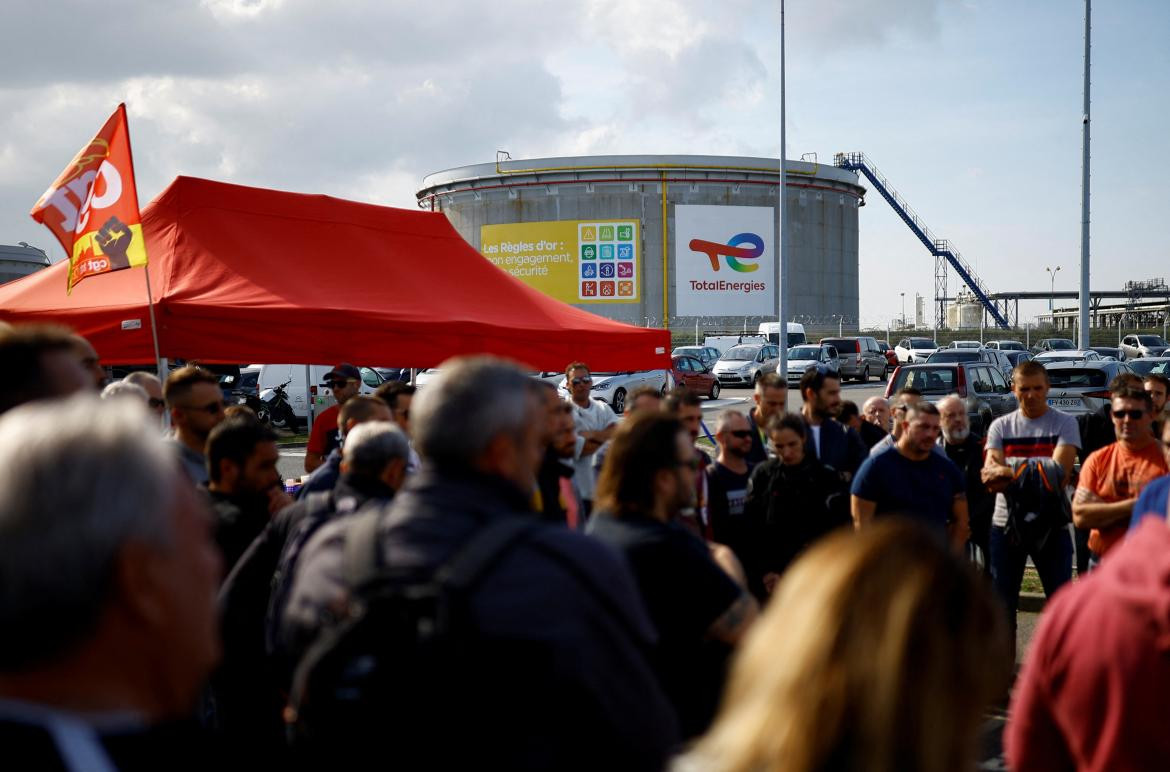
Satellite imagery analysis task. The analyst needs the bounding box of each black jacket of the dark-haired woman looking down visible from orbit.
[744,451,852,591]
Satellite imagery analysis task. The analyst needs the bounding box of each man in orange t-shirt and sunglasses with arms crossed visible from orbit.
[1073,388,1170,560]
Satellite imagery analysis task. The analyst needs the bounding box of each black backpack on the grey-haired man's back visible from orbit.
[285,510,539,768]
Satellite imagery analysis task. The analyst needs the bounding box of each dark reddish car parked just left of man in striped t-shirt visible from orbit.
[886,360,1018,434]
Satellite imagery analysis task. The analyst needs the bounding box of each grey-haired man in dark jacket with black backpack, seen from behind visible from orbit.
[276,357,676,770]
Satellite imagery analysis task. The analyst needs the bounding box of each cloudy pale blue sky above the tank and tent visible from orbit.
[0,0,1170,324]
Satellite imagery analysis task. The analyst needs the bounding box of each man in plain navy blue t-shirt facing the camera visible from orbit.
[852,402,969,552]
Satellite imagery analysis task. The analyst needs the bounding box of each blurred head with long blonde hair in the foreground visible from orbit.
[695,518,1010,772]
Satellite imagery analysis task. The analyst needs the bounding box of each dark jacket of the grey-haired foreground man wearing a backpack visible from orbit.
[283,468,677,770]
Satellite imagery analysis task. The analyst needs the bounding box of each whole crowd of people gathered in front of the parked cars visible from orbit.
[0,325,1170,772]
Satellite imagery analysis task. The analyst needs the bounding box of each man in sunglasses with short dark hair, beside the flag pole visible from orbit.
[163,365,223,484]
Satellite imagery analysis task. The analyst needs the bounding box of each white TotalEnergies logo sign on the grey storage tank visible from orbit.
[674,205,776,316]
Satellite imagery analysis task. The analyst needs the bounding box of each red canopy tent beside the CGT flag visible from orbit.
[0,177,670,371]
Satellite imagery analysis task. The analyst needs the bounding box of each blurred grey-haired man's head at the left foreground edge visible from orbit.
[0,393,220,721]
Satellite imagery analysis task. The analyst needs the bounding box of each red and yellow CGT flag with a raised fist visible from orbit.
[29,104,146,292]
